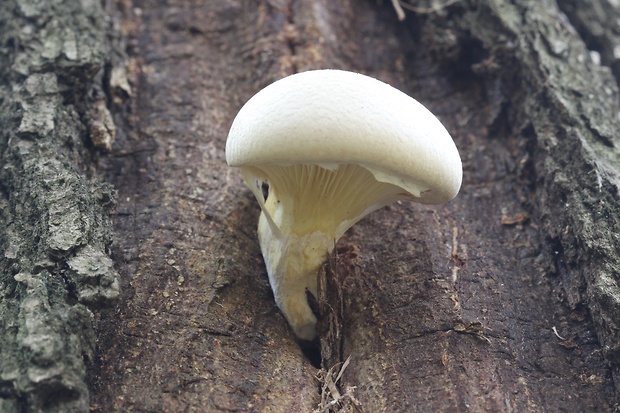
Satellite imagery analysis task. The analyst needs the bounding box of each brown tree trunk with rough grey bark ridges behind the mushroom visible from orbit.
[0,0,620,413]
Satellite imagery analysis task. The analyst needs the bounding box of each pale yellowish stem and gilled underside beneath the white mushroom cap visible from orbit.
[243,164,412,340]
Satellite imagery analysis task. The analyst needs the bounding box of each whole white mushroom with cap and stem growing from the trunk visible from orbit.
[226,70,463,340]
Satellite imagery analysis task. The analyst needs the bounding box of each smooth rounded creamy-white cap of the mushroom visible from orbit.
[226,70,463,204]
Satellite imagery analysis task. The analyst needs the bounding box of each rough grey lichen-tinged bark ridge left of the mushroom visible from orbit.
[0,0,119,412]
